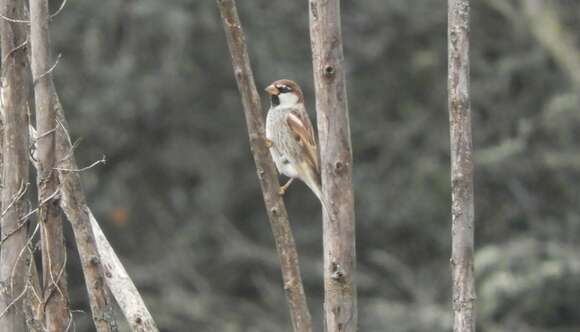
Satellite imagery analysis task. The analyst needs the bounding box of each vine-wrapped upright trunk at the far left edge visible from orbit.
[0,0,28,332]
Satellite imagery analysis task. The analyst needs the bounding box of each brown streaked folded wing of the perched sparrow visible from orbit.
[286,109,320,174]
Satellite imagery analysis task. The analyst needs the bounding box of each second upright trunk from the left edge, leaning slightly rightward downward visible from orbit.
[30,0,70,331]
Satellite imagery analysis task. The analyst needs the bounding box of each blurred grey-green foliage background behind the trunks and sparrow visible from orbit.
[51,0,580,332]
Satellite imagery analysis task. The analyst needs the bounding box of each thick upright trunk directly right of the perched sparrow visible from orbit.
[309,0,357,332]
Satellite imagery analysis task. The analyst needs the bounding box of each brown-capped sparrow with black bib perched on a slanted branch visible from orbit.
[265,79,325,207]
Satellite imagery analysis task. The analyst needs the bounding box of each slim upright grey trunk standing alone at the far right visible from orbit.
[447,0,475,332]
